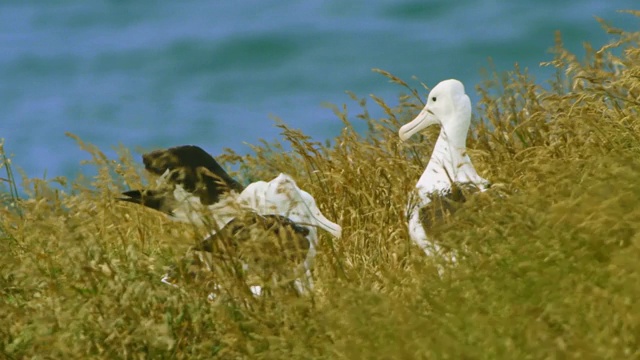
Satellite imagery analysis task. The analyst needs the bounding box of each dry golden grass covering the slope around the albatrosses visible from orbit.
[0,12,640,359]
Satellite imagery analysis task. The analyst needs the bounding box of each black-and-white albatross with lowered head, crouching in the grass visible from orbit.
[121,145,342,293]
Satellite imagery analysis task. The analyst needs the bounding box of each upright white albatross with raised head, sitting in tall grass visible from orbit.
[399,79,490,260]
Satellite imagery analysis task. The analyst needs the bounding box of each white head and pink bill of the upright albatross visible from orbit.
[399,79,471,141]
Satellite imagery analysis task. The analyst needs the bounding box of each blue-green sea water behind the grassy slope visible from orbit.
[0,0,640,178]
